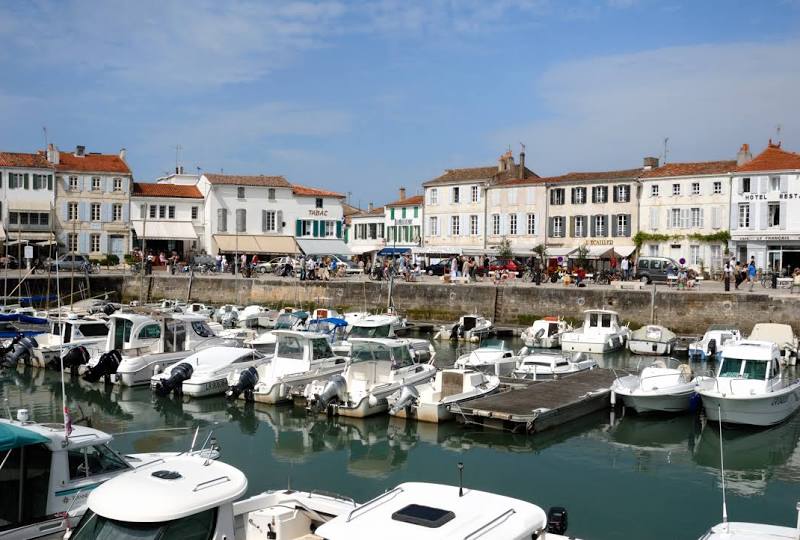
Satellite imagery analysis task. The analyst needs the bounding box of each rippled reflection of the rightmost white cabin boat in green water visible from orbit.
[692,414,800,496]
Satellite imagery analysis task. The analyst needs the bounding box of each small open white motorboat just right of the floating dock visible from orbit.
[611,359,697,413]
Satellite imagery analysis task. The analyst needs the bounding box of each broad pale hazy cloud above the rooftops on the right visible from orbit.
[490,41,800,175]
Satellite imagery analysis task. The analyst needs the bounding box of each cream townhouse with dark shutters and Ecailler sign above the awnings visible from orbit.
[542,166,640,259]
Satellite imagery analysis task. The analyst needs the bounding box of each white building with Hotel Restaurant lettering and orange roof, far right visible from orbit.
[730,141,800,272]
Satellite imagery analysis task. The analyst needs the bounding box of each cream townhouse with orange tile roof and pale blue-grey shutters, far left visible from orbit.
[47,144,133,260]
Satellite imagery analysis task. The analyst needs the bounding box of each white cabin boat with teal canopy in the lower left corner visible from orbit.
[0,409,218,540]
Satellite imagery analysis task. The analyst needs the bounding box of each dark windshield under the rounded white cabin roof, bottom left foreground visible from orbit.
[71,508,217,540]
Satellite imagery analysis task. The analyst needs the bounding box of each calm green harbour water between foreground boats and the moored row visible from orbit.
[0,342,800,539]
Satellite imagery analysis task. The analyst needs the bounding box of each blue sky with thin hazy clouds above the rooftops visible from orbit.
[0,0,800,207]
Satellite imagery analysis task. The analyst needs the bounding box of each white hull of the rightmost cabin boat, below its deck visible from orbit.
[699,383,800,426]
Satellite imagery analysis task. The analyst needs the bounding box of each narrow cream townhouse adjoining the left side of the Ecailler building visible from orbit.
[486,176,547,257]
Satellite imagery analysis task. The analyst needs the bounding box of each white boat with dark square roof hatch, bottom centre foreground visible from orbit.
[315,482,580,540]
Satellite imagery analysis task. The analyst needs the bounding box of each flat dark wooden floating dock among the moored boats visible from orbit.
[453,368,620,433]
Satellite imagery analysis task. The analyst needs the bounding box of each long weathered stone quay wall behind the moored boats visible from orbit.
[6,275,800,335]
